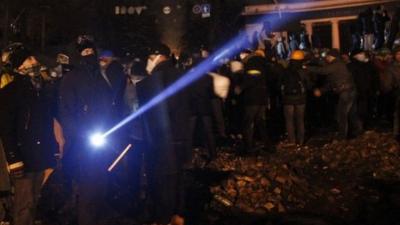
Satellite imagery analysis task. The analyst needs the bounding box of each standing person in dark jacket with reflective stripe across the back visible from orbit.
[235,51,271,153]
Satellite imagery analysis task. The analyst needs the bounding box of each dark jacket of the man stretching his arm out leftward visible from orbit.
[308,59,354,94]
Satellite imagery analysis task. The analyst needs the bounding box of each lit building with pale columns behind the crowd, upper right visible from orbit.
[242,0,400,49]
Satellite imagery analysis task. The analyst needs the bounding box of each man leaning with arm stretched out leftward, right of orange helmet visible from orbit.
[309,49,361,139]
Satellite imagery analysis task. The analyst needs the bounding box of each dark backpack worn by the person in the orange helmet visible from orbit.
[281,70,306,96]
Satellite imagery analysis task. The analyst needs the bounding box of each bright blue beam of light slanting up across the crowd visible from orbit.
[102,12,294,138]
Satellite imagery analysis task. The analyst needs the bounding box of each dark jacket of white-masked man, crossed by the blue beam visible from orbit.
[137,61,190,173]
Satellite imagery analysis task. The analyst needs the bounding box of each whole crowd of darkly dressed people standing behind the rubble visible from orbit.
[0,16,400,225]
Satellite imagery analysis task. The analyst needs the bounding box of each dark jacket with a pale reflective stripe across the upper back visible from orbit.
[240,56,268,105]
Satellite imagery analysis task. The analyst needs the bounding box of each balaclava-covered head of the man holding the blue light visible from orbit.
[76,35,98,67]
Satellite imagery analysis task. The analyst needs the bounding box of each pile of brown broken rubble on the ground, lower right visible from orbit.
[203,131,400,214]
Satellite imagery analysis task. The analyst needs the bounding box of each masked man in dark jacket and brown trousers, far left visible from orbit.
[0,44,58,225]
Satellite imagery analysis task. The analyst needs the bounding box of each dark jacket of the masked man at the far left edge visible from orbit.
[1,75,57,172]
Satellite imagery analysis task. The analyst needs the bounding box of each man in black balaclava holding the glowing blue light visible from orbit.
[59,35,123,225]
